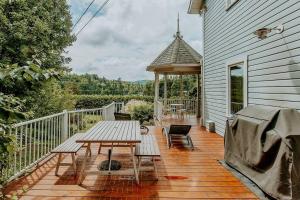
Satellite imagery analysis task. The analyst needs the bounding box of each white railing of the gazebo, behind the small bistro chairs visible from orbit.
[162,99,197,115]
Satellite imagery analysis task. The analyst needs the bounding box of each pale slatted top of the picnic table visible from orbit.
[76,121,141,143]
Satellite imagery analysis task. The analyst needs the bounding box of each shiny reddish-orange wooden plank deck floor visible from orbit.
[6,119,256,200]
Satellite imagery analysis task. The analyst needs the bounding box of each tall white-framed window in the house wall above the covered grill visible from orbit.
[227,55,248,116]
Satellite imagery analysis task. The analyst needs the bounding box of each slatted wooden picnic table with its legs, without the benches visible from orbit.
[76,121,141,184]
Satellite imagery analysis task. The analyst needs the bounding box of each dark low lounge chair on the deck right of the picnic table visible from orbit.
[162,125,194,150]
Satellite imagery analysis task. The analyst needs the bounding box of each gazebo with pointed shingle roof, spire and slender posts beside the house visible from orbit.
[147,16,202,117]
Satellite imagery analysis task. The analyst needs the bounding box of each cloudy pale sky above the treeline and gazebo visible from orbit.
[67,0,203,81]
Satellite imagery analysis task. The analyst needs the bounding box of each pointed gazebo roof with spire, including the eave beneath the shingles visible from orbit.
[147,15,202,74]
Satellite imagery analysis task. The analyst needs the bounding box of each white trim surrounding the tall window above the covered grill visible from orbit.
[226,55,248,117]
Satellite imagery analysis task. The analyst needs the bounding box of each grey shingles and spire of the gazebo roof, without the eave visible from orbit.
[147,16,202,71]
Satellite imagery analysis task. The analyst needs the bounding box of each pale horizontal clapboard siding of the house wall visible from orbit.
[204,0,300,135]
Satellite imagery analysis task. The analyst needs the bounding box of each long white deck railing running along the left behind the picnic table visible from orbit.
[1,103,124,180]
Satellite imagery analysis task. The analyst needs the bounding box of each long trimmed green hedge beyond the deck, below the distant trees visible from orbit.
[73,95,154,109]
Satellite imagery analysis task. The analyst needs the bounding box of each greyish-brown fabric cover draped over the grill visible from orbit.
[225,106,300,199]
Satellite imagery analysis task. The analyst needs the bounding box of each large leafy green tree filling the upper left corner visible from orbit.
[0,0,75,117]
